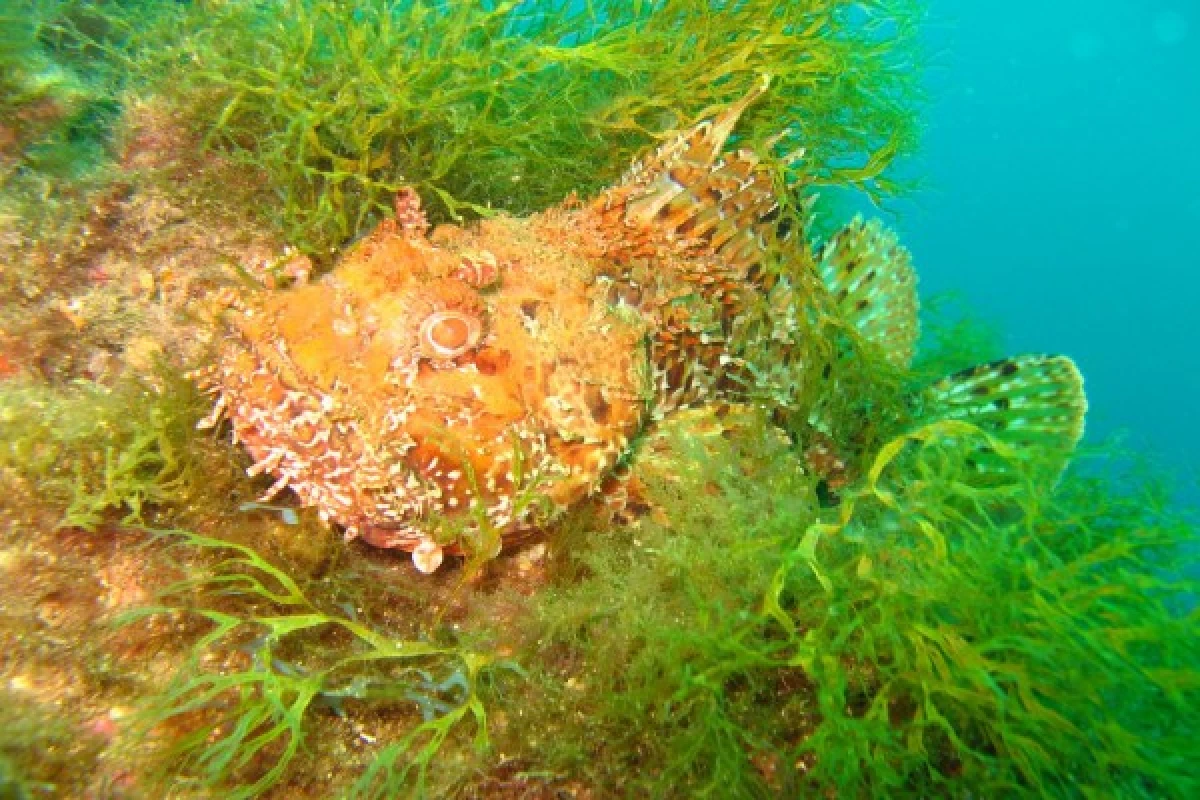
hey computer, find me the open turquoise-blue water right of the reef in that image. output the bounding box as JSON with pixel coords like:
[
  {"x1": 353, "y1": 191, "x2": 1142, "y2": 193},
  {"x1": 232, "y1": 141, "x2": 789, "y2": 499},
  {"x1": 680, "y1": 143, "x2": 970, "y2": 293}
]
[{"x1": 890, "y1": 0, "x2": 1200, "y2": 501}]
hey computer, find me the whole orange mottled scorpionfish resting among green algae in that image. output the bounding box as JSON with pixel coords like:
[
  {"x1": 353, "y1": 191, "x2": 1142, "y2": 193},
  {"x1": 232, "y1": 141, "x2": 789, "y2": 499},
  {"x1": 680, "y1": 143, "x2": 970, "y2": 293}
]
[{"x1": 198, "y1": 78, "x2": 1085, "y2": 572}]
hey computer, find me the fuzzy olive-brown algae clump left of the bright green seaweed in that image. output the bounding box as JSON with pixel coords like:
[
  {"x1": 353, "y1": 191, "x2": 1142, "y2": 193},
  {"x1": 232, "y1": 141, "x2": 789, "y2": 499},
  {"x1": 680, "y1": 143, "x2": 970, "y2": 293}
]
[{"x1": 504, "y1": 420, "x2": 817, "y2": 796}]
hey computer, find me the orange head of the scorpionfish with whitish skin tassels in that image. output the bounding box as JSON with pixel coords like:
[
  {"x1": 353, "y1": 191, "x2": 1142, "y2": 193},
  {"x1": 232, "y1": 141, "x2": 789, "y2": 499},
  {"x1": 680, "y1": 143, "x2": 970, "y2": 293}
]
[{"x1": 210, "y1": 209, "x2": 650, "y2": 566}]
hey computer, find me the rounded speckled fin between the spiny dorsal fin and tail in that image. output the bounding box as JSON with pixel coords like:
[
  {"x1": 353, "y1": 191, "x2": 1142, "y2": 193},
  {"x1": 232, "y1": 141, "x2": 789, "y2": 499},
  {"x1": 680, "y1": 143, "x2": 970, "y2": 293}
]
[{"x1": 817, "y1": 217, "x2": 918, "y2": 367}]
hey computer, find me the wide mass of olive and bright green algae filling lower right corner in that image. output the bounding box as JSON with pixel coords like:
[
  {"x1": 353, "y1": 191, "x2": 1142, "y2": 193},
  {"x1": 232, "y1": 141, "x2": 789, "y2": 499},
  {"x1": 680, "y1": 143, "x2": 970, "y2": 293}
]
[{"x1": 506, "y1": 328, "x2": 1200, "y2": 796}]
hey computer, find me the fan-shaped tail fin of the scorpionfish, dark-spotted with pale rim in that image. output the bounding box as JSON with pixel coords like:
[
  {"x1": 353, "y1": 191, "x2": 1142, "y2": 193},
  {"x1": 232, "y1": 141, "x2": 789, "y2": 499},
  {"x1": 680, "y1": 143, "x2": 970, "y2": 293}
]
[{"x1": 923, "y1": 355, "x2": 1087, "y2": 475}]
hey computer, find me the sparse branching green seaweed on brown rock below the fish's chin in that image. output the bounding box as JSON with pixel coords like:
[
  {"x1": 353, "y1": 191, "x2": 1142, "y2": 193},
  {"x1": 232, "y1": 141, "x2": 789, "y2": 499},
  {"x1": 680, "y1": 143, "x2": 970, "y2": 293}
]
[{"x1": 119, "y1": 530, "x2": 514, "y2": 799}]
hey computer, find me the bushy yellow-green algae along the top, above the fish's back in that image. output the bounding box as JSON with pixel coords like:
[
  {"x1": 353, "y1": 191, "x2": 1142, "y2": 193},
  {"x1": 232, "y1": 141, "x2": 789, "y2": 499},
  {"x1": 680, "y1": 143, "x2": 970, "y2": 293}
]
[{"x1": 110, "y1": 0, "x2": 917, "y2": 253}]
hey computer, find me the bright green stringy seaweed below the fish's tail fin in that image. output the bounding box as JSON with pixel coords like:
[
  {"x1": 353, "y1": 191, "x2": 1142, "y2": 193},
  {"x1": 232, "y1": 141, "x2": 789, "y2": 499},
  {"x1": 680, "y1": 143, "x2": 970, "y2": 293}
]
[{"x1": 766, "y1": 423, "x2": 1200, "y2": 796}]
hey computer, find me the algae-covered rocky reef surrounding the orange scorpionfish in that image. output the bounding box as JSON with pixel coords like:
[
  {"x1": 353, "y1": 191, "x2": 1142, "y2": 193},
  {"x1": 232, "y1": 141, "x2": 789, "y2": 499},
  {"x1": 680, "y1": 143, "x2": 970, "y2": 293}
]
[{"x1": 0, "y1": 0, "x2": 1200, "y2": 798}]
